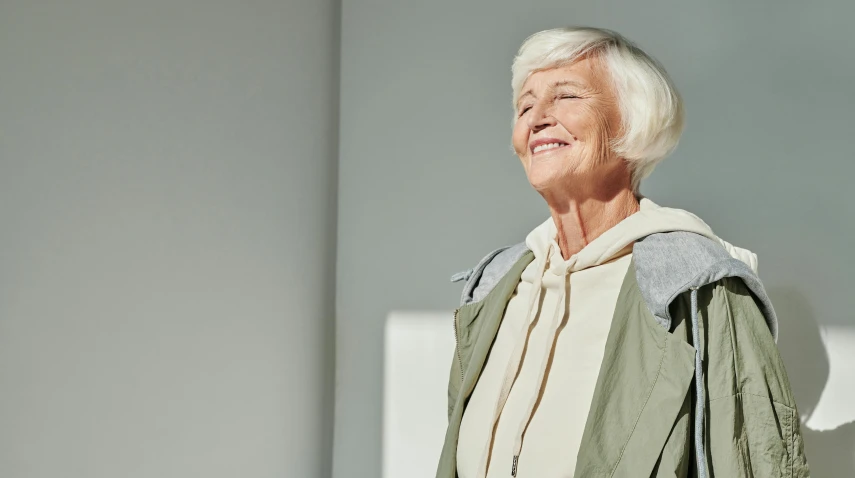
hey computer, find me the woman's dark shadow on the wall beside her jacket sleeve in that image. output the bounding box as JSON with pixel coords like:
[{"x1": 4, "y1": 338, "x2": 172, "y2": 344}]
[{"x1": 767, "y1": 287, "x2": 855, "y2": 478}]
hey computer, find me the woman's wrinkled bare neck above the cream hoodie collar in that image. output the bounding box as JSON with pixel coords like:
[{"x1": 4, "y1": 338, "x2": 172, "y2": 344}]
[{"x1": 544, "y1": 187, "x2": 640, "y2": 259}]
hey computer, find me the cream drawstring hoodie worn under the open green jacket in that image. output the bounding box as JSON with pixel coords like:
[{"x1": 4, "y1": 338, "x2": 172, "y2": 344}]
[{"x1": 457, "y1": 197, "x2": 757, "y2": 478}]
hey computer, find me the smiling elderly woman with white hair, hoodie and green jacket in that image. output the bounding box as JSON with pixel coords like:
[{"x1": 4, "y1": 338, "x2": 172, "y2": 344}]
[{"x1": 437, "y1": 28, "x2": 809, "y2": 478}]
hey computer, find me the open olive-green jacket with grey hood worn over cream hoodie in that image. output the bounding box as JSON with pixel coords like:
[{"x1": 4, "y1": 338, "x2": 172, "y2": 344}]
[{"x1": 436, "y1": 232, "x2": 809, "y2": 478}]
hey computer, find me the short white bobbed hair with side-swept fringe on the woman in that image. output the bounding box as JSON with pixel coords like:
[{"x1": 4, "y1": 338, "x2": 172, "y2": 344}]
[{"x1": 511, "y1": 27, "x2": 684, "y2": 193}]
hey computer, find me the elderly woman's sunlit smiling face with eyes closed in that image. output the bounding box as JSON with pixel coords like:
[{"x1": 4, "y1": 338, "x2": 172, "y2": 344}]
[{"x1": 512, "y1": 58, "x2": 625, "y2": 193}]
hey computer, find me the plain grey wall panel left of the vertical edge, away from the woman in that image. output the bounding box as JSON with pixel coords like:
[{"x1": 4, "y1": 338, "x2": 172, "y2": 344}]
[{"x1": 0, "y1": 0, "x2": 339, "y2": 478}]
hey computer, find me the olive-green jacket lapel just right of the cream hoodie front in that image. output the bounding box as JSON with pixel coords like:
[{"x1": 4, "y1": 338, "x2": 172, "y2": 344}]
[{"x1": 574, "y1": 260, "x2": 694, "y2": 477}]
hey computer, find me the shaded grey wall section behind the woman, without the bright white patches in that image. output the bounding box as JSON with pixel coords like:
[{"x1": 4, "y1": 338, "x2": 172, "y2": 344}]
[{"x1": 334, "y1": 0, "x2": 855, "y2": 478}]
